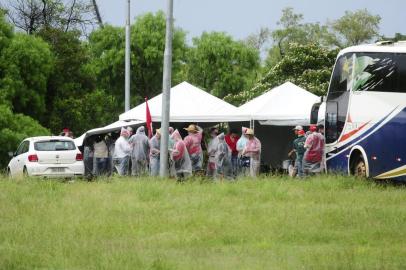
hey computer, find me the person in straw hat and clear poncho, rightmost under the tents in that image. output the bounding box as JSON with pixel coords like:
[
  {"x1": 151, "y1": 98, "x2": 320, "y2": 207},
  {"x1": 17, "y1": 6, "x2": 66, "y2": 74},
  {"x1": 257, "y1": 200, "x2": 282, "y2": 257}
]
[{"x1": 242, "y1": 128, "x2": 261, "y2": 177}]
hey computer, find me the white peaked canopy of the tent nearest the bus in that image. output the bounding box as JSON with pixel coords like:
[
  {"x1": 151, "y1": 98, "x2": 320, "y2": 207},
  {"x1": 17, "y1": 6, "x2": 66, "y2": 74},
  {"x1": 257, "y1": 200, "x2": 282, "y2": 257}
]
[{"x1": 238, "y1": 82, "x2": 320, "y2": 126}]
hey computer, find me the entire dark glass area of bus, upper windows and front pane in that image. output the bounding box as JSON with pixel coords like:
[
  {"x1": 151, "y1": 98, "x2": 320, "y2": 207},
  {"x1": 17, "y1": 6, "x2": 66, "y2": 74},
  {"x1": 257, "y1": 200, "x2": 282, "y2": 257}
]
[{"x1": 325, "y1": 52, "x2": 406, "y2": 143}]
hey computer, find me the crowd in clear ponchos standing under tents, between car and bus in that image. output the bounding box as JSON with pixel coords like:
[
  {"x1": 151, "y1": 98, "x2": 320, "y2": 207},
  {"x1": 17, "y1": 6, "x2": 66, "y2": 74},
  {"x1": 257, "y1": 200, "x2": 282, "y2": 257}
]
[{"x1": 84, "y1": 124, "x2": 261, "y2": 179}]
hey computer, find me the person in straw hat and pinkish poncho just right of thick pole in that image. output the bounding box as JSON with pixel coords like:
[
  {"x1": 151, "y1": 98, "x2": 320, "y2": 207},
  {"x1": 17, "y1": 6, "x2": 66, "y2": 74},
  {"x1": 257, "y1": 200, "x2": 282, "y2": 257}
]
[{"x1": 183, "y1": 124, "x2": 203, "y2": 173}]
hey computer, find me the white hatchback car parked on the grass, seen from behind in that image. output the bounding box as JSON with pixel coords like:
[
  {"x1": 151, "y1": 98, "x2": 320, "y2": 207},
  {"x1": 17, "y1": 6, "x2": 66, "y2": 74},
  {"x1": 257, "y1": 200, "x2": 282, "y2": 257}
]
[{"x1": 7, "y1": 136, "x2": 85, "y2": 177}]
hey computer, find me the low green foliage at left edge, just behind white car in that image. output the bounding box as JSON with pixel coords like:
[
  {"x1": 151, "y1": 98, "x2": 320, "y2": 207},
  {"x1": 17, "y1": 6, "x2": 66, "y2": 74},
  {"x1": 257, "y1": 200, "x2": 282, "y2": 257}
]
[{"x1": 0, "y1": 105, "x2": 49, "y2": 169}]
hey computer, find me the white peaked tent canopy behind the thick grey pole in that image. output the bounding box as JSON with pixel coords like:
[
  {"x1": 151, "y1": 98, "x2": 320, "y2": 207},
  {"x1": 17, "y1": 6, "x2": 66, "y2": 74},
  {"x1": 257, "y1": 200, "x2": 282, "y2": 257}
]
[{"x1": 119, "y1": 82, "x2": 244, "y2": 123}]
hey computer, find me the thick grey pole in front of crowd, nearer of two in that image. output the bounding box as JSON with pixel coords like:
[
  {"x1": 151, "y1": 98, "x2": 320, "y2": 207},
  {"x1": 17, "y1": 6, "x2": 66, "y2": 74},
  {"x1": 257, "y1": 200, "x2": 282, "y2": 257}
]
[{"x1": 159, "y1": 0, "x2": 173, "y2": 177}]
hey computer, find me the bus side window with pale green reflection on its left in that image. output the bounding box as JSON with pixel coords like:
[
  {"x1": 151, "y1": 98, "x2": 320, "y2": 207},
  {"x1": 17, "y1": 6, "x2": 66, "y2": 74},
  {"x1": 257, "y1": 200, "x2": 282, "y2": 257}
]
[{"x1": 352, "y1": 52, "x2": 396, "y2": 92}]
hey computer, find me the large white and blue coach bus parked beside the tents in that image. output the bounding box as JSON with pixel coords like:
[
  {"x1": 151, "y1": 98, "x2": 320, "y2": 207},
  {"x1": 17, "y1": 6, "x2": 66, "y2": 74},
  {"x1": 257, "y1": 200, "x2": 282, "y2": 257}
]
[{"x1": 311, "y1": 42, "x2": 406, "y2": 181}]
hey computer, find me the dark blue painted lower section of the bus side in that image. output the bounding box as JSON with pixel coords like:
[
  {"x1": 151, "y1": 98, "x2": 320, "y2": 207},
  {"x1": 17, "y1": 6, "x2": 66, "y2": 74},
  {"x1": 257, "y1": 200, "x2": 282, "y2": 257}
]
[{"x1": 327, "y1": 108, "x2": 406, "y2": 180}]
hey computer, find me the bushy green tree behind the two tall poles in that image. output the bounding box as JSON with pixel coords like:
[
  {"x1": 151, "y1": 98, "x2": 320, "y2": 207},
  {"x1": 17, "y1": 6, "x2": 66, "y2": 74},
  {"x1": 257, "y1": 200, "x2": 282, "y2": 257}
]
[{"x1": 88, "y1": 12, "x2": 186, "y2": 106}]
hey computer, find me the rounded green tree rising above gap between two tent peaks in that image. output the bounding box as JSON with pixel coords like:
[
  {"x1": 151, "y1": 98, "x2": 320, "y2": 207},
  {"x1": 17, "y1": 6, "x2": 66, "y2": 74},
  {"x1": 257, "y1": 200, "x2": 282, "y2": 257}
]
[{"x1": 187, "y1": 32, "x2": 260, "y2": 101}]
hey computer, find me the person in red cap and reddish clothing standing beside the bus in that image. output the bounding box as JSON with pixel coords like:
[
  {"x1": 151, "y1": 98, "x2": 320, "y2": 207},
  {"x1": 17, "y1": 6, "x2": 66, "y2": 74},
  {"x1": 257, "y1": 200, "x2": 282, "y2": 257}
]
[{"x1": 303, "y1": 125, "x2": 324, "y2": 175}]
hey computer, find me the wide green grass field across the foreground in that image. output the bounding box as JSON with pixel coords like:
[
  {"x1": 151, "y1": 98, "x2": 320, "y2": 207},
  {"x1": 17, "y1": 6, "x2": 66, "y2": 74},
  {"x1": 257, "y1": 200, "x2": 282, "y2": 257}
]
[{"x1": 0, "y1": 176, "x2": 406, "y2": 269}]
